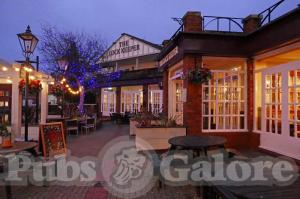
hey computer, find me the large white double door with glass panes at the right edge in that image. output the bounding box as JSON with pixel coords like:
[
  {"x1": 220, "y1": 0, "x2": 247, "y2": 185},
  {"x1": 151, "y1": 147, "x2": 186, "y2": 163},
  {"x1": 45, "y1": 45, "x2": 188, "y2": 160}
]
[{"x1": 261, "y1": 62, "x2": 300, "y2": 159}]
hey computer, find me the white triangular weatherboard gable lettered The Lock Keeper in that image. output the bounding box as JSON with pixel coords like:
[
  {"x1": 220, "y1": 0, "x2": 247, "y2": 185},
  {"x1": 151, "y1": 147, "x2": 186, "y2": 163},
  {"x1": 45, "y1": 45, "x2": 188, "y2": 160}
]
[{"x1": 100, "y1": 34, "x2": 160, "y2": 63}]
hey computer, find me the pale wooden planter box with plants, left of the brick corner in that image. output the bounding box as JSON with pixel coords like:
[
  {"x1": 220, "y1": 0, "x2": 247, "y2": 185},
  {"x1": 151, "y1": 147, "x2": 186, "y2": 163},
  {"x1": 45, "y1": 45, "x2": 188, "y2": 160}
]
[{"x1": 134, "y1": 127, "x2": 186, "y2": 150}]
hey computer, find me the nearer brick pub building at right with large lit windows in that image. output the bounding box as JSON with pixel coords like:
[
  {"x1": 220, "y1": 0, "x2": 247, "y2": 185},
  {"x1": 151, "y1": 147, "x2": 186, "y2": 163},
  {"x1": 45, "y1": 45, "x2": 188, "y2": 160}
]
[{"x1": 158, "y1": 4, "x2": 300, "y2": 160}]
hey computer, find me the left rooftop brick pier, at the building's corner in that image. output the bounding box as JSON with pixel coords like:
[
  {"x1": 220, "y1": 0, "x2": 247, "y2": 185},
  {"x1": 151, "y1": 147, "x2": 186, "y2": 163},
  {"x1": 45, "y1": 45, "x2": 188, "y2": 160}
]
[{"x1": 182, "y1": 11, "x2": 202, "y2": 32}]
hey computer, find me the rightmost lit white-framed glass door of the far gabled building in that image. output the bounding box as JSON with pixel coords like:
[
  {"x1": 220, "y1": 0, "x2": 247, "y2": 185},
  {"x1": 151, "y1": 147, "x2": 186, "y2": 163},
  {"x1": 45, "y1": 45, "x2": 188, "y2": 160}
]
[{"x1": 148, "y1": 90, "x2": 163, "y2": 114}]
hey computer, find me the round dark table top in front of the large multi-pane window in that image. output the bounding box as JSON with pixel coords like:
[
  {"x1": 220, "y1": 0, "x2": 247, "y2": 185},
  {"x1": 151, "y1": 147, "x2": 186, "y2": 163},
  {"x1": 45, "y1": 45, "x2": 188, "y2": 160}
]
[{"x1": 168, "y1": 136, "x2": 226, "y2": 156}]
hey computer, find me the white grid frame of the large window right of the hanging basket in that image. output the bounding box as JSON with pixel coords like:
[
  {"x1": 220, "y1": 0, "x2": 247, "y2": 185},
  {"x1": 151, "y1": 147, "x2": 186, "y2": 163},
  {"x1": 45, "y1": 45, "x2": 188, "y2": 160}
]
[{"x1": 202, "y1": 67, "x2": 248, "y2": 133}]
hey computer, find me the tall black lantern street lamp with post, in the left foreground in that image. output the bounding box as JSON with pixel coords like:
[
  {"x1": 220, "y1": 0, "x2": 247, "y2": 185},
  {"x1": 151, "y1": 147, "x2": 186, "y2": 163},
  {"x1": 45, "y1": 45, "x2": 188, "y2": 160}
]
[{"x1": 17, "y1": 26, "x2": 39, "y2": 141}]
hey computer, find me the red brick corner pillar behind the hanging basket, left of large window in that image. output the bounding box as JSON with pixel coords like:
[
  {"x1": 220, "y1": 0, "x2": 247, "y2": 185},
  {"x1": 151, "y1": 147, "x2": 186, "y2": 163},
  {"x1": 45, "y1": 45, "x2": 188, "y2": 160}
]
[{"x1": 183, "y1": 55, "x2": 202, "y2": 135}]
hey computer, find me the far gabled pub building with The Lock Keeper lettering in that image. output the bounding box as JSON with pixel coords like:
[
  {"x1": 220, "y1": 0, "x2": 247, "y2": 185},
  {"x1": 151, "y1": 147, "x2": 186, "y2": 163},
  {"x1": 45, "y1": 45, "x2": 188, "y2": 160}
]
[{"x1": 97, "y1": 33, "x2": 163, "y2": 117}]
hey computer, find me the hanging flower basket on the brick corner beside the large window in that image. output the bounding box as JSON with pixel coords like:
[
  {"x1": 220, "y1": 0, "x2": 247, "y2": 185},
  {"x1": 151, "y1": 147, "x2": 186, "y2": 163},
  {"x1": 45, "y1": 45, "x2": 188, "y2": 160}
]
[{"x1": 189, "y1": 68, "x2": 212, "y2": 84}]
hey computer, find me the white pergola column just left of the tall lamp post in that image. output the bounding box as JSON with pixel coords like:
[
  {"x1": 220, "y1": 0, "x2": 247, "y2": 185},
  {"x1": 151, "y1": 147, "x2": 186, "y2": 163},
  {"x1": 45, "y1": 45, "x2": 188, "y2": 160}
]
[{"x1": 11, "y1": 76, "x2": 22, "y2": 140}]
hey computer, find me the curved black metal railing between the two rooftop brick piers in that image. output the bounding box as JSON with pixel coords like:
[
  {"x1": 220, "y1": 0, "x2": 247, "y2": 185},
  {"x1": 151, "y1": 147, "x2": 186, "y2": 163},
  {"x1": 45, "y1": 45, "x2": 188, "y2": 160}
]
[{"x1": 202, "y1": 16, "x2": 244, "y2": 32}]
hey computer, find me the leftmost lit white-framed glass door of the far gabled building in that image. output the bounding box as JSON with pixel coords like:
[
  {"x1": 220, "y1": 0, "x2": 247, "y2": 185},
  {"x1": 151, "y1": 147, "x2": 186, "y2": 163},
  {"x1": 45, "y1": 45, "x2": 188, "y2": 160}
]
[{"x1": 102, "y1": 91, "x2": 116, "y2": 116}]
